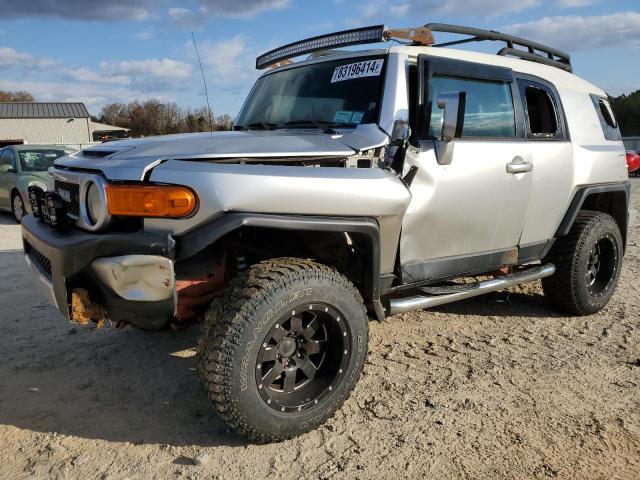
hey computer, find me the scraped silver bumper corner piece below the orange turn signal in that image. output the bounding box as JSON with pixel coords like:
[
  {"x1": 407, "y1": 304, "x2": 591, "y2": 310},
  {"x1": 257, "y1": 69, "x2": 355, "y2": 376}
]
[{"x1": 91, "y1": 255, "x2": 175, "y2": 302}]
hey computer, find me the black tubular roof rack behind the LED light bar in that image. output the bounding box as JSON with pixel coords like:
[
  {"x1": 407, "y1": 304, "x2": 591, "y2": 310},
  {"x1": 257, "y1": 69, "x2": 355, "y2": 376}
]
[{"x1": 424, "y1": 23, "x2": 573, "y2": 72}]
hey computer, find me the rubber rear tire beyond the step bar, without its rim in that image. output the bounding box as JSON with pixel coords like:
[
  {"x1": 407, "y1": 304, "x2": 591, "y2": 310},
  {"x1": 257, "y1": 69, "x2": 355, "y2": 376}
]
[{"x1": 542, "y1": 210, "x2": 624, "y2": 315}]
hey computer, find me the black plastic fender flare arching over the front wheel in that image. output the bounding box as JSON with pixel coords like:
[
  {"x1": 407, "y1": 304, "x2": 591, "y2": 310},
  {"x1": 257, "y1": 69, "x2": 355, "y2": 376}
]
[{"x1": 175, "y1": 213, "x2": 380, "y2": 300}]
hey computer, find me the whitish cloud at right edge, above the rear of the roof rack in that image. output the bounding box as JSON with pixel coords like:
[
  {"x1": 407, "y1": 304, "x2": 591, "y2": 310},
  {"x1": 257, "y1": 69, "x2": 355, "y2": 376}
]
[{"x1": 503, "y1": 12, "x2": 640, "y2": 51}]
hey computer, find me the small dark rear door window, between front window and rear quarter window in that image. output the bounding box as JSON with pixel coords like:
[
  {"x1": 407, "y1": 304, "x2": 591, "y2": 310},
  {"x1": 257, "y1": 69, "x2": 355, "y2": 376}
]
[{"x1": 518, "y1": 79, "x2": 565, "y2": 140}]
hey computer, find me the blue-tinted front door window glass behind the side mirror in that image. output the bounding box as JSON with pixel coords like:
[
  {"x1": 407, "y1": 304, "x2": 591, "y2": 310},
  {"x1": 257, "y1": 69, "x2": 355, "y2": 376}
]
[{"x1": 425, "y1": 75, "x2": 516, "y2": 138}]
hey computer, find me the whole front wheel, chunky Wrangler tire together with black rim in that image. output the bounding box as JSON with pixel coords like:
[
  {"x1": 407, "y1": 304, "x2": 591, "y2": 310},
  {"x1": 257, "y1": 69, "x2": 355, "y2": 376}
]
[{"x1": 198, "y1": 258, "x2": 368, "y2": 443}]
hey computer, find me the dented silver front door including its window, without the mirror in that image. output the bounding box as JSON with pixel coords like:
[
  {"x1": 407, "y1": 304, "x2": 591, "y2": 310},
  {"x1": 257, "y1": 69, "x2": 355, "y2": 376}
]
[{"x1": 400, "y1": 56, "x2": 533, "y2": 282}]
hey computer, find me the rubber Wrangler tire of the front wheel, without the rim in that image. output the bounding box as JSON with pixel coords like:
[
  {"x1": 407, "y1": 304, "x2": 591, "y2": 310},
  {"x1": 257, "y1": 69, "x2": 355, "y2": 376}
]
[{"x1": 197, "y1": 258, "x2": 368, "y2": 443}]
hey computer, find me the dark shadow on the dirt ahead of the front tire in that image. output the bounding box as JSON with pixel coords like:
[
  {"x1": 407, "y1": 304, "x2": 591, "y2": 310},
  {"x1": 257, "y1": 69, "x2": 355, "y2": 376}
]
[{"x1": 0, "y1": 251, "x2": 244, "y2": 446}]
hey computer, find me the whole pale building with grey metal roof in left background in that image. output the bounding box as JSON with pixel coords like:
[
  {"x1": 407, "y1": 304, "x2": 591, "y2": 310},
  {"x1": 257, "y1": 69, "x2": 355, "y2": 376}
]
[{"x1": 0, "y1": 102, "x2": 126, "y2": 148}]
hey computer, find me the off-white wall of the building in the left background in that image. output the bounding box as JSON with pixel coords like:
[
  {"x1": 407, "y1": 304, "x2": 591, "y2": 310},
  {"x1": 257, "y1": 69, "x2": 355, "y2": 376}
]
[{"x1": 0, "y1": 118, "x2": 92, "y2": 144}]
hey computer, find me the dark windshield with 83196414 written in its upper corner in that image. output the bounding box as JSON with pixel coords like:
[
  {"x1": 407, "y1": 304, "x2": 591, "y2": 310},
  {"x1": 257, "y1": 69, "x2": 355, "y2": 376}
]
[{"x1": 236, "y1": 55, "x2": 385, "y2": 129}]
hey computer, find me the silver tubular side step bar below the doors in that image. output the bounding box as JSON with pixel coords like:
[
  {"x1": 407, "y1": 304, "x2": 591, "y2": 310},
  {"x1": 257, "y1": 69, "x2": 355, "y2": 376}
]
[{"x1": 389, "y1": 263, "x2": 556, "y2": 315}]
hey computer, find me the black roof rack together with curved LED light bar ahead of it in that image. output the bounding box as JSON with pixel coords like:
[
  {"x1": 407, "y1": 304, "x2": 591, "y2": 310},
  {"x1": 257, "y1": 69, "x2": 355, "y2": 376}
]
[{"x1": 256, "y1": 23, "x2": 572, "y2": 72}]
